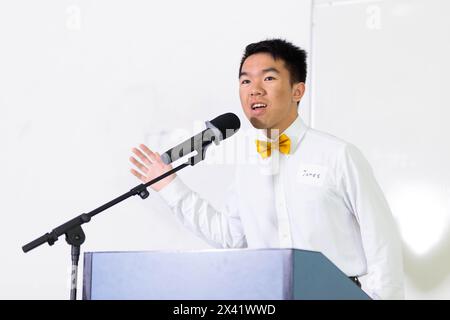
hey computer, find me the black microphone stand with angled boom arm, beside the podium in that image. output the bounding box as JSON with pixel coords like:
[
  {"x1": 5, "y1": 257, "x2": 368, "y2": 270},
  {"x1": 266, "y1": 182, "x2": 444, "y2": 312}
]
[{"x1": 22, "y1": 156, "x2": 197, "y2": 300}]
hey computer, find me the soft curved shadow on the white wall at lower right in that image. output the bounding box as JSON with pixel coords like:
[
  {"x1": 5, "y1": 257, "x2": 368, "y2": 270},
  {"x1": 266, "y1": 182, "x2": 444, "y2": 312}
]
[{"x1": 403, "y1": 228, "x2": 450, "y2": 291}]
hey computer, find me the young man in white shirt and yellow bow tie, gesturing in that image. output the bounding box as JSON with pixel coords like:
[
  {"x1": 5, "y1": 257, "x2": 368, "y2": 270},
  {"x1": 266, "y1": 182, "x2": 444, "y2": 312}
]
[{"x1": 130, "y1": 39, "x2": 403, "y2": 299}]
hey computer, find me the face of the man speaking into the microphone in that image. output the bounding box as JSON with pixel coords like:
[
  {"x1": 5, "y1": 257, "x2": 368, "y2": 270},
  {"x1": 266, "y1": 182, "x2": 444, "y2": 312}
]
[{"x1": 239, "y1": 53, "x2": 304, "y2": 136}]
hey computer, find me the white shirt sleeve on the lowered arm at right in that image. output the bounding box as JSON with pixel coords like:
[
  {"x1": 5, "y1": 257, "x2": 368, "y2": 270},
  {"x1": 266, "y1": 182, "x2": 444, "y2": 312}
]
[{"x1": 341, "y1": 144, "x2": 404, "y2": 299}]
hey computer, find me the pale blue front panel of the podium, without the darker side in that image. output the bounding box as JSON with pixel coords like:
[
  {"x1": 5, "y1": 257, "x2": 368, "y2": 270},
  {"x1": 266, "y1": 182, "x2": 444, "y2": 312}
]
[{"x1": 83, "y1": 249, "x2": 292, "y2": 300}]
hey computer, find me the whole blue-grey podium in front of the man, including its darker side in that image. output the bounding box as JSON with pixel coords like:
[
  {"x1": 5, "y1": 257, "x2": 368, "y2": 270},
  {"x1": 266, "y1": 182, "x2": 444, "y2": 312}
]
[{"x1": 83, "y1": 249, "x2": 370, "y2": 300}]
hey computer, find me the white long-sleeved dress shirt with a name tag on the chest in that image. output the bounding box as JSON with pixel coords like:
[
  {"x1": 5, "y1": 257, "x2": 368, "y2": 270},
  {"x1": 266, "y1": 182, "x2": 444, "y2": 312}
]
[{"x1": 159, "y1": 117, "x2": 404, "y2": 299}]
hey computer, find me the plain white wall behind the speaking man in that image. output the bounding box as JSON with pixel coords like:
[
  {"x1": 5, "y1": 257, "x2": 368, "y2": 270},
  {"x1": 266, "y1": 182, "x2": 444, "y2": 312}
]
[{"x1": 0, "y1": 0, "x2": 450, "y2": 299}]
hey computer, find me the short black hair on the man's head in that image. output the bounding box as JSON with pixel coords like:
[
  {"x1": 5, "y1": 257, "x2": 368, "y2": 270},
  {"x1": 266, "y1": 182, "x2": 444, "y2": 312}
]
[{"x1": 239, "y1": 39, "x2": 307, "y2": 84}]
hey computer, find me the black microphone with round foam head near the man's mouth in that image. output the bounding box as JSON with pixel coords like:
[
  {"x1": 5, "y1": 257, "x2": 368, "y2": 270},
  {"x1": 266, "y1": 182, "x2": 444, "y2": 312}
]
[{"x1": 161, "y1": 112, "x2": 241, "y2": 165}]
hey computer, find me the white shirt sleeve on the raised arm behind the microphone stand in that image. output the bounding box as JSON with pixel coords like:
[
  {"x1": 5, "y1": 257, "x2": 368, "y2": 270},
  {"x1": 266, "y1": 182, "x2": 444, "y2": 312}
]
[{"x1": 158, "y1": 176, "x2": 247, "y2": 248}]
